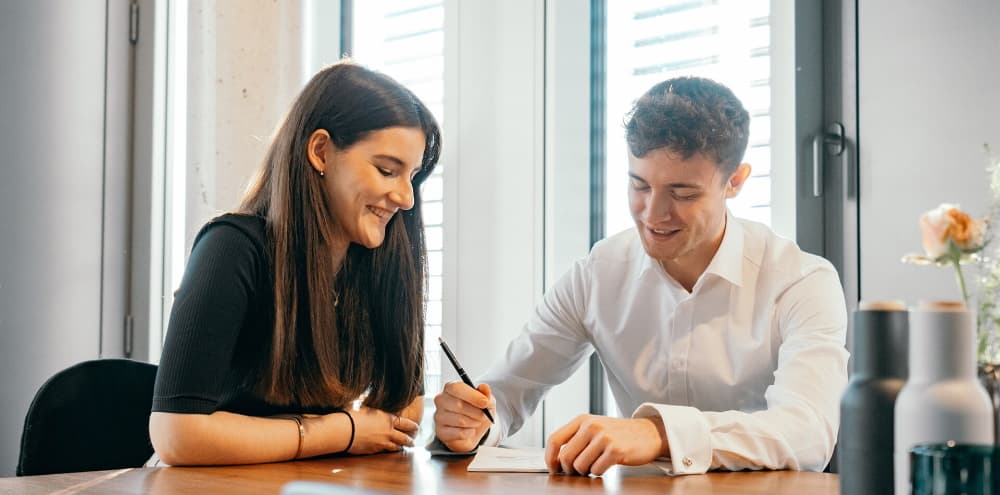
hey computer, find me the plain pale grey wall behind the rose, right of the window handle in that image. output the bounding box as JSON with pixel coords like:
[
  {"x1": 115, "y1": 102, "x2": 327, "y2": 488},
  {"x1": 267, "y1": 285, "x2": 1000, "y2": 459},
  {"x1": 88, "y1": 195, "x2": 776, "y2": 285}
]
[{"x1": 858, "y1": 0, "x2": 1000, "y2": 304}]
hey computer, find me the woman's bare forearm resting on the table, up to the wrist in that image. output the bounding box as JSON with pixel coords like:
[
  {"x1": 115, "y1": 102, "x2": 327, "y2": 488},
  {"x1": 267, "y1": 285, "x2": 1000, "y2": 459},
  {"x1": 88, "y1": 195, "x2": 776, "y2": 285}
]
[{"x1": 149, "y1": 411, "x2": 352, "y2": 466}]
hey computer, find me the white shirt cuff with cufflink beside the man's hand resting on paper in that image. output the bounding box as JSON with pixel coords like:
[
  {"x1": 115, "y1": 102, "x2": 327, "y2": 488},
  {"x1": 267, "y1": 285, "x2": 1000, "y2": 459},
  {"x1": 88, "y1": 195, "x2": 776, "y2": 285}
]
[{"x1": 632, "y1": 402, "x2": 712, "y2": 474}]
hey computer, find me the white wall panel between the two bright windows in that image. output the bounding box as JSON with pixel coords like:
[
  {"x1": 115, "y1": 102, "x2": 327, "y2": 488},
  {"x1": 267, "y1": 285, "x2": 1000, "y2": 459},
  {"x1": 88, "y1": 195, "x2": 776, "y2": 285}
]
[{"x1": 441, "y1": 0, "x2": 544, "y2": 450}]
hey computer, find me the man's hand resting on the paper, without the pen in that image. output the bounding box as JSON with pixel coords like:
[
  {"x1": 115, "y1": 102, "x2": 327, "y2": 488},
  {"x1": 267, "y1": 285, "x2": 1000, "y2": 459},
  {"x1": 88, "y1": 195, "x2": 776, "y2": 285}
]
[{"x1": 545, "y1": 414, "x2": 670, "y2": 476}]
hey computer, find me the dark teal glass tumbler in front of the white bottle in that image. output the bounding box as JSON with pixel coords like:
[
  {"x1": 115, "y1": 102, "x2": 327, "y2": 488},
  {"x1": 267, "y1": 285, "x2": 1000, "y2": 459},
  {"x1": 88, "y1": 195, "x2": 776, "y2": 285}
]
[{"x1": 910, "y1": 442, "x2": 1000, "y2": 495}]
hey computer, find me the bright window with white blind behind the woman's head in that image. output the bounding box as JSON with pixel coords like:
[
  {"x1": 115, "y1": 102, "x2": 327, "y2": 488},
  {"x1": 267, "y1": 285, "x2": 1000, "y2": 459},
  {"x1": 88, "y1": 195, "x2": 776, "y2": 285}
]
[{"x1": 351, "y1": 0, "x2": 444, "y2": 393}]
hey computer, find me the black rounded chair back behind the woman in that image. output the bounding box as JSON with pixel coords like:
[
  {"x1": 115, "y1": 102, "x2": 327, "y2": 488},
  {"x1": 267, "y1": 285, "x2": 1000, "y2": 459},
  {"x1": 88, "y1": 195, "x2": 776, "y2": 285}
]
[{"x1": 17, "y1": 359, "x2": 156, "y2": 476}]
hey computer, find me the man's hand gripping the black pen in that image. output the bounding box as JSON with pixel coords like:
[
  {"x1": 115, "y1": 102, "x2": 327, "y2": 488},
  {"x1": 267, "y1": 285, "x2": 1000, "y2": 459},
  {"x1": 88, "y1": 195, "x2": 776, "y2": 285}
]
[{"x1": 434, "y1": 381, "x2": 496, "y2": 452}]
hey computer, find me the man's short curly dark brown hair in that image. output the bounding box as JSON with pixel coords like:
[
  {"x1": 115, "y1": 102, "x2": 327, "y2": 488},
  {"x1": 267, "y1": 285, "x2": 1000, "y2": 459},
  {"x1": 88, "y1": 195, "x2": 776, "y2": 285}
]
[{"x1": 625, "y1": 77, "x2": 750, "y2": 177}]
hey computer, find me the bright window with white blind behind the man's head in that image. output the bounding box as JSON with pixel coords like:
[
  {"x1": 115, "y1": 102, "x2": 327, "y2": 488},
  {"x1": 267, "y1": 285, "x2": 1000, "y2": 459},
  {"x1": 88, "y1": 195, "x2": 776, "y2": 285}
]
[{"x1": 605, "y1": 0, "x2": 771, "y2": 235}]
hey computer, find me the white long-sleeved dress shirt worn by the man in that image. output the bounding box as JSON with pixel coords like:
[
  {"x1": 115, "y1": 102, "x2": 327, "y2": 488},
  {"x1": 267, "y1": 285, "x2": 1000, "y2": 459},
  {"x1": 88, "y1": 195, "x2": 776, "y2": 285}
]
[{"x1": 480, "y1": 214, "x2": 848, "y2": 474}]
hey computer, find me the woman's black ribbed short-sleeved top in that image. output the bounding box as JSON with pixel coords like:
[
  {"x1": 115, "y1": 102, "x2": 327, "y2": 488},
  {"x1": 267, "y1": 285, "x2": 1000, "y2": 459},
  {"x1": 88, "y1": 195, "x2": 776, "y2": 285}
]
[{"x1": 153, "y1": 214, "x2": 335, "y2": 416}]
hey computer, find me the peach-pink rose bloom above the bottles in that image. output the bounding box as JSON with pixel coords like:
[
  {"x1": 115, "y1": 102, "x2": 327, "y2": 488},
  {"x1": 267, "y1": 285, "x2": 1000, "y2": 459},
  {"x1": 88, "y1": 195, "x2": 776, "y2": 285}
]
[{"x1": 920, "y1": 203, "x2": 986, "y2": 259}]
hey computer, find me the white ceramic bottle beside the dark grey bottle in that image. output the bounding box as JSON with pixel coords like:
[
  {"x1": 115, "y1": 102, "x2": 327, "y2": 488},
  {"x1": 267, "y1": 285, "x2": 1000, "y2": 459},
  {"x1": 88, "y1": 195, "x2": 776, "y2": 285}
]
[{"x1": 894, "y1": 301, "x2": 993, "y2": 495}]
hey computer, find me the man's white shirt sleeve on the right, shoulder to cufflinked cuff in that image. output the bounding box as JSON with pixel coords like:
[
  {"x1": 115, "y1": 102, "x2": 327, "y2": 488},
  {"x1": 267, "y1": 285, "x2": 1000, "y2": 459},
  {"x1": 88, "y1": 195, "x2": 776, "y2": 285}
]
[{"x1": 632, "y1": 268, "x2": 848, "y2": 474}]
